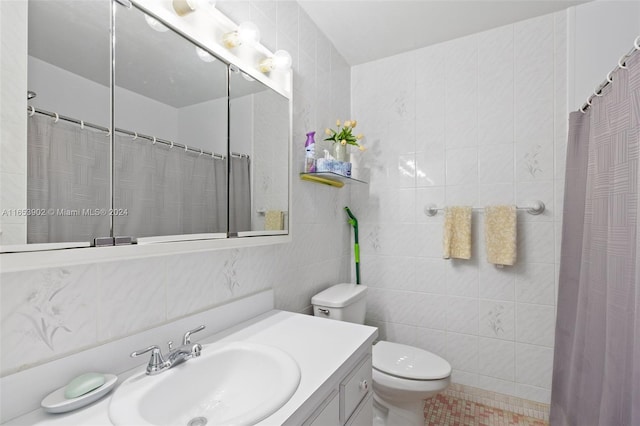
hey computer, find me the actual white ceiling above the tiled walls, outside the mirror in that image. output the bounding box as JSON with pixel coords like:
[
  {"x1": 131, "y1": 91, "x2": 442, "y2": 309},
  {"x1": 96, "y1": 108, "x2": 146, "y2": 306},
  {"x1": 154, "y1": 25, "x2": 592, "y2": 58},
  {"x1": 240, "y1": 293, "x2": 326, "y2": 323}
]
[{"x1": 299, "y1": 0, "x2": 590, "y2": 65}]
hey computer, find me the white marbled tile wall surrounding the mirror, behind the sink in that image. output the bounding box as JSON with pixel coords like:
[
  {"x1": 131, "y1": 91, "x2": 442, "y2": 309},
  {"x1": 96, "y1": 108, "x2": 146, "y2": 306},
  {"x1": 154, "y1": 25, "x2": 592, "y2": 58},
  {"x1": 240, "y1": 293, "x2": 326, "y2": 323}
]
[{"x1": 0, "y1": 1, "x2": 351, "y2": 375}]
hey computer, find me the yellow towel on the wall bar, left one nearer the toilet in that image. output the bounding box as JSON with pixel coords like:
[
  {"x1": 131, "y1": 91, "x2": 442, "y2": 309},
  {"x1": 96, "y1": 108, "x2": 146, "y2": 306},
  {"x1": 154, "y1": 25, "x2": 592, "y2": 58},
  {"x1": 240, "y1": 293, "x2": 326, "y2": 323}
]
[{"x1": 442, "y1": 206, "x2": 471, "y2": 259}]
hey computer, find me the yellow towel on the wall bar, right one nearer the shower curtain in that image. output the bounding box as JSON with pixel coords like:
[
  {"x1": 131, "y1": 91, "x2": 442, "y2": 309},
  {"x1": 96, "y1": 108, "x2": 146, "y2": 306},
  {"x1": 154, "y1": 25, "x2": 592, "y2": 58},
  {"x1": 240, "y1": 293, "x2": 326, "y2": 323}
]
[{"x1": 484, "y1": 206, "x2": 516, "y2": 266}]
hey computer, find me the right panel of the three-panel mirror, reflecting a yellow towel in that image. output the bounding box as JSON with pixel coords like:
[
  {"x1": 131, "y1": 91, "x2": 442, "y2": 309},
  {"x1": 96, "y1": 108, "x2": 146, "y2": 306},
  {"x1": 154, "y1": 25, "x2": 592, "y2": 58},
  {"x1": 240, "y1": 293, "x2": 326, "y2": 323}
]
[{"x1": 229, "y1": 71, "x2": 290, "y2": 237}]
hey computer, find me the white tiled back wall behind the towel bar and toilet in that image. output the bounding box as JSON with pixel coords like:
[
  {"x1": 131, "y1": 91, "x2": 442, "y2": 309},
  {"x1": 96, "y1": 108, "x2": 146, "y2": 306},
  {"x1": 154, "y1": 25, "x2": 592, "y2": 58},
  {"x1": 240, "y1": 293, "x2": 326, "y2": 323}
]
[{"x1": 351, "y1": 12, "x2": 568, "y2": 402}]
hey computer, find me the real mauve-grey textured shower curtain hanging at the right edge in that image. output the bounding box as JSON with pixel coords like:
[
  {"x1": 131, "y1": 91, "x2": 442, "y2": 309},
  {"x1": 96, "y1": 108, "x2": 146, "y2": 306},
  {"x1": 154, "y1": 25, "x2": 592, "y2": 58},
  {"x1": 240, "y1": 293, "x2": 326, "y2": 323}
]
[{"x1": 550, "y1": 53, "x2": 640, "y2": 426}]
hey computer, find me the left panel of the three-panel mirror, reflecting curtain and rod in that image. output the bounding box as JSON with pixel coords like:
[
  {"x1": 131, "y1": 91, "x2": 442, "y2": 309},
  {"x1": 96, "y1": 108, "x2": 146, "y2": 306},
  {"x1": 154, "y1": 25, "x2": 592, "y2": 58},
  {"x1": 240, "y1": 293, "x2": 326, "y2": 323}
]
[{"x1": 21, "y1": 0, "x2": 111, "y2": 245}]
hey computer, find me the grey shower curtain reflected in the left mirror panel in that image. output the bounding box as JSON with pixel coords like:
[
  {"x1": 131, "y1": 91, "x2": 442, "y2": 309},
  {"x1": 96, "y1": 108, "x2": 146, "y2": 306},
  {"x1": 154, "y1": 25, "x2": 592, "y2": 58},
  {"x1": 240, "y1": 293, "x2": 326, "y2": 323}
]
[{"x1": 27, "y1": 115, "x2": 111, "y2": 244}]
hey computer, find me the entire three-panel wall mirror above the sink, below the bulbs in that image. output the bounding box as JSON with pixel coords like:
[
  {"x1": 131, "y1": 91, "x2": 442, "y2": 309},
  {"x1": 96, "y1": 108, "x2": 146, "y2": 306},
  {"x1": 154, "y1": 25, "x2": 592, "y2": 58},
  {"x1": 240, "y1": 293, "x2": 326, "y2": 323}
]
[{"x1": 2, "y1": 0, "x2": 291, "y2": 252}]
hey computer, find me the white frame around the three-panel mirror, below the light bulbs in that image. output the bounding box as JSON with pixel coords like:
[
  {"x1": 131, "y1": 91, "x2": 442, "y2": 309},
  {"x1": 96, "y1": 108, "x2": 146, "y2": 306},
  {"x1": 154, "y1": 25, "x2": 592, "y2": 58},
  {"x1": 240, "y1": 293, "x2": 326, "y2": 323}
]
[{"x1": 0, "y1": 0, "x2": 293, "y2": 272}]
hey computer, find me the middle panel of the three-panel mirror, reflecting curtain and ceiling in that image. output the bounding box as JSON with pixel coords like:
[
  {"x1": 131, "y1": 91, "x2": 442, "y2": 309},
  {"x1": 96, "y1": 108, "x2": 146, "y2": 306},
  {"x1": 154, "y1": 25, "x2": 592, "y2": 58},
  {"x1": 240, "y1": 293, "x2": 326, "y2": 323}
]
[{"x1": 114, "y1": 6, "x2": 228, "y2": 243}]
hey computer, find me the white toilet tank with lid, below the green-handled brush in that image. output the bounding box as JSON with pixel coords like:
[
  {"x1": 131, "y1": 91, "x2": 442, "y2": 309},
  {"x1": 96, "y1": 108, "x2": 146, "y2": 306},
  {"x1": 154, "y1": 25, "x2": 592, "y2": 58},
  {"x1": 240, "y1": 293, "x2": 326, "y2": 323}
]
[{"x1": 311, "y1": 284, "x2": 367, "y2": 324}]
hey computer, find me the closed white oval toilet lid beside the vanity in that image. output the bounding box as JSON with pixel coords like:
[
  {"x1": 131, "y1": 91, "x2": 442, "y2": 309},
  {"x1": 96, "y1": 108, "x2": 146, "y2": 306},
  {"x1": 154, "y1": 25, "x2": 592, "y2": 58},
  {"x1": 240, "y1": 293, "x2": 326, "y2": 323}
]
[{"x1": 372, "y1": 341, "x2": 451, "y2": 380}]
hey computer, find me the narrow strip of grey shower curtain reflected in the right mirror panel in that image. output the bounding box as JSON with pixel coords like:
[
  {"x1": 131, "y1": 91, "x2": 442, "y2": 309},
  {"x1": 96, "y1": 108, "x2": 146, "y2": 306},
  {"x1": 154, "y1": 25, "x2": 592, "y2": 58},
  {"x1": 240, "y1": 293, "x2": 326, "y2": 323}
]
[{"x1": 229, "y1": 156, "x2": 251, "y2": 233}]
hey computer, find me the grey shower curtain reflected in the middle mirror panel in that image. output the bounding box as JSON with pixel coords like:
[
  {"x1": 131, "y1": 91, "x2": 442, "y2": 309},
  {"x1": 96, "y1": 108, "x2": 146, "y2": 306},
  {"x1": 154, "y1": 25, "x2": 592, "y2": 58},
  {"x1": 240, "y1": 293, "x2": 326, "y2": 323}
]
[{"x1": 114, "y1": 133, "x2": 227, "y2": 237}]
